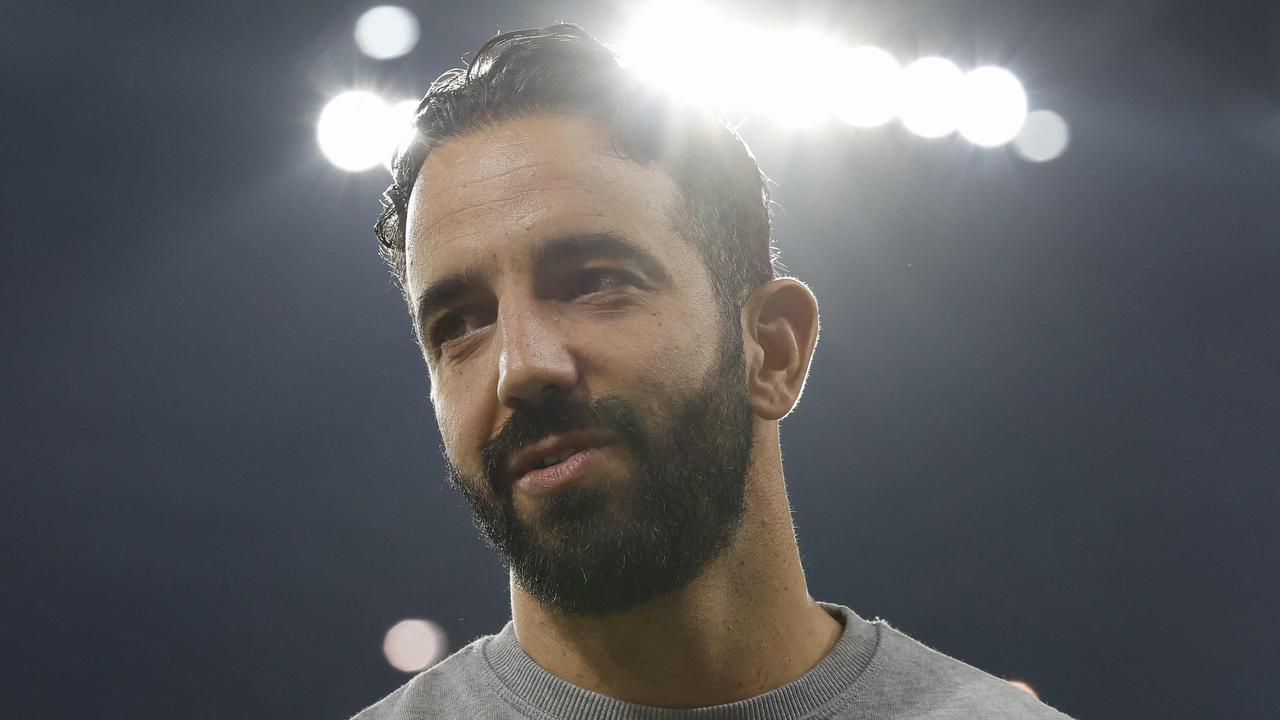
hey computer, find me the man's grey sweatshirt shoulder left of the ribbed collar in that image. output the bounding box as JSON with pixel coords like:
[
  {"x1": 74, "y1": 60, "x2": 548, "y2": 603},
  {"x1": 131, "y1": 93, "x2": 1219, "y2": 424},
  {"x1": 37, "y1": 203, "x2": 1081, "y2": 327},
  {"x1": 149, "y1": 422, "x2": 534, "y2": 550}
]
[{"x1": 351, "y1": 635, "x2": 493, "y2": 720}]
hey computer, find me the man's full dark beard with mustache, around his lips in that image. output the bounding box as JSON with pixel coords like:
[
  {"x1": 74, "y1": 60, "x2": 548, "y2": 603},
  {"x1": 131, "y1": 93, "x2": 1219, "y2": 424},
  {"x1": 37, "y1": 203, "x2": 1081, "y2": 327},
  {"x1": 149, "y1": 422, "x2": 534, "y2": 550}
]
[{"x1": 445, "y1": 316, "x2": 751, "y2": 616}]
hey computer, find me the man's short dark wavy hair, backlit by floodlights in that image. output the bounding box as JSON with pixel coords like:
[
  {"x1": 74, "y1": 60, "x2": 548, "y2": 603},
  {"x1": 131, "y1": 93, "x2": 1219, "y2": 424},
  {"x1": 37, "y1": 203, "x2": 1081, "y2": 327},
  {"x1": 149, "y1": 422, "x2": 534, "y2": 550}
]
[{"x1": 374, "y1": 24, "x2": 780, "y2": 315}]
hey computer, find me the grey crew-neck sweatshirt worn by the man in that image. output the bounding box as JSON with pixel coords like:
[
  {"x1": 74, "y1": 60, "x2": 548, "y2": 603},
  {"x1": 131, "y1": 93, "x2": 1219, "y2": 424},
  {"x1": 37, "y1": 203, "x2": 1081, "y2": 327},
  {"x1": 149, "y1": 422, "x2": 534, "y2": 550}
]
[{"x1": 353, "y1": 602, "x2": 1070, "y2": 720}]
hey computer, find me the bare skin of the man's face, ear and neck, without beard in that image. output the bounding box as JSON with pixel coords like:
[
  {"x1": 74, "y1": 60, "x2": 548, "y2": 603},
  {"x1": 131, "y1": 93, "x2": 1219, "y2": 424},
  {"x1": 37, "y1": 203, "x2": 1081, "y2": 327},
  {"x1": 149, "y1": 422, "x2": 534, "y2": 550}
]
[{"x1": 406, "y1": 114, "x2": 842, "y2": 707}]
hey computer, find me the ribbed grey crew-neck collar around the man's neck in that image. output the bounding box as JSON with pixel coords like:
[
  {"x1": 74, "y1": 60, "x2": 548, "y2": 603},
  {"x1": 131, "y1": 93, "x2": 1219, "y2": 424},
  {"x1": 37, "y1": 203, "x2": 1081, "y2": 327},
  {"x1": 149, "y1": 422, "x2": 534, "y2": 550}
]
[{"x1": 484, "y1": 602, "x2": 881, "y2": 720}]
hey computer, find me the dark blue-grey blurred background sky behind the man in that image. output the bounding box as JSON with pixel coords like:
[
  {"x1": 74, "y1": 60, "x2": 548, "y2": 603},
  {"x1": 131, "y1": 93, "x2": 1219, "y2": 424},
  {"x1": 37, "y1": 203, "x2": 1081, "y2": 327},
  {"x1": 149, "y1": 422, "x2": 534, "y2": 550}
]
[{"x1": 0, "y1": 0, "x2": 1280, "y2": 719}]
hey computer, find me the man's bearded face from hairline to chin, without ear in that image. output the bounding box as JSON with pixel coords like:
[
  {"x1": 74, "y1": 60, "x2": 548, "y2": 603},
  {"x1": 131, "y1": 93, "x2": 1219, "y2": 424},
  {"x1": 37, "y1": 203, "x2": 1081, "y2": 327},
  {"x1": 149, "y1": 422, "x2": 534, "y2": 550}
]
[{"x1": 406, "y1": 114, "x2": 753, "y2": 615}]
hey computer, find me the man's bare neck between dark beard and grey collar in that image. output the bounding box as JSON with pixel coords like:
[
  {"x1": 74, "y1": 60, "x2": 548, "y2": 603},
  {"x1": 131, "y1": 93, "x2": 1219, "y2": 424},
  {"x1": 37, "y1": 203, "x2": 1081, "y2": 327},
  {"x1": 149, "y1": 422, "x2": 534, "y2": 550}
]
[{"x1": 511, "y1": 424, "x2": 841, "y2": 707}]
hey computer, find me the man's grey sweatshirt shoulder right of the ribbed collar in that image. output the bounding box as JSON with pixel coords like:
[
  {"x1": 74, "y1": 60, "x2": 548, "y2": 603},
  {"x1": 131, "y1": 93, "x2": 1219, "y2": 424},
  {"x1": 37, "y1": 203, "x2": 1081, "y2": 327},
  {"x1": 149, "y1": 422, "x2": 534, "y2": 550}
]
[{"x1": 864, "y1": 620, "x2": 1070, "y2": 720}]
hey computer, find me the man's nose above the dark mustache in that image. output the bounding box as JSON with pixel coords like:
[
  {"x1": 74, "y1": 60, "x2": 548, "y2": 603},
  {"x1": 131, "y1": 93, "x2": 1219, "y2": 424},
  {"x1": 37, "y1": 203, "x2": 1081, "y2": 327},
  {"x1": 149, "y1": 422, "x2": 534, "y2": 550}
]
[{"x1": 497, "y1": 298, "x2": 579, "y2": 407}]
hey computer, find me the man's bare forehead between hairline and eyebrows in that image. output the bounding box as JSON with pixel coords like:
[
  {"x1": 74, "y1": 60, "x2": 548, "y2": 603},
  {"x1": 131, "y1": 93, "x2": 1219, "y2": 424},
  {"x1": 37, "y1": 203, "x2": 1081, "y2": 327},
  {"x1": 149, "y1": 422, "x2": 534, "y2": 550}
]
[{"x1": 404, "y1": 114, "x2": 680, "y2": 284}]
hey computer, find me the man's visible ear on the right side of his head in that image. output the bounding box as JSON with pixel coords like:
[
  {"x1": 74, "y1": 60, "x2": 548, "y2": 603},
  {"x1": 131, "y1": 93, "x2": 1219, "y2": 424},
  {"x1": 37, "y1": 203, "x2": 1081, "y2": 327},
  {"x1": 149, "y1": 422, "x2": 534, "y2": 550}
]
[{"x1": 742, "y1": 278, "x2": 818, "y2": 420}]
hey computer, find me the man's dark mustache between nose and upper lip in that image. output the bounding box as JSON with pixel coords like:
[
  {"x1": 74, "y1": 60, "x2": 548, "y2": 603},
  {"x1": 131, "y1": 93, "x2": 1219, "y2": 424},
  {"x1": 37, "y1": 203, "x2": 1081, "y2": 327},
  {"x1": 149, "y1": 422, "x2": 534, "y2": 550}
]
[{"x1": 480, "y1": 392, "x2": 648, "y2": 493}]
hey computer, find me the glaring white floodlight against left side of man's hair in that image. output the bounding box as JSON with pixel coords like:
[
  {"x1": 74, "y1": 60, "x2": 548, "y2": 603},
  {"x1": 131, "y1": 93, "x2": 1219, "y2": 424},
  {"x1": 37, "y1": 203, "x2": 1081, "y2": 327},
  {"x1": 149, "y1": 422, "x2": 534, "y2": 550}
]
[{"x1": 316, "y1": 90, "x2": 417, "y2": 173}]
